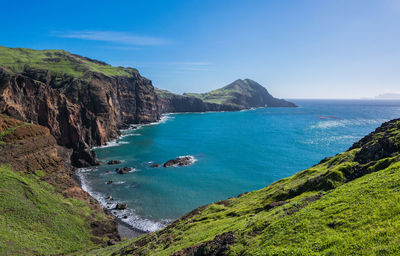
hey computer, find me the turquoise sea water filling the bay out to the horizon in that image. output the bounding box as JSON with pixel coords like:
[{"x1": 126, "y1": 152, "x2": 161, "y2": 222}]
[{"x1": 79, "y1": 100, "x2": 400, "y2": 231}]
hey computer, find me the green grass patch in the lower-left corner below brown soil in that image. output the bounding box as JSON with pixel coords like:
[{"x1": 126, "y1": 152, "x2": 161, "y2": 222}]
[{"x1": 0, "y1": 166, "x2": 104, "y2": 255}]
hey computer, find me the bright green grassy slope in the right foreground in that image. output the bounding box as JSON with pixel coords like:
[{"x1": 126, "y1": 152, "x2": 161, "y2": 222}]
[{"x1": 88, "y1": 121, "x2": 400, "y2": 255}]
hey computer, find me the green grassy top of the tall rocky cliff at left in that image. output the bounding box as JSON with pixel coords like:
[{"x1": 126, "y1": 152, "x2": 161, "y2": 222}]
[{"x1": 0, "y1": 46, "x2": 137, "y2": 77}]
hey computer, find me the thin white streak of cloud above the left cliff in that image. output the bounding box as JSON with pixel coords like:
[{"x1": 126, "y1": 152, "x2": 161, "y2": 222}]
[{"x1": 54, "y1": 31, "x2": 171, "y2": 46}]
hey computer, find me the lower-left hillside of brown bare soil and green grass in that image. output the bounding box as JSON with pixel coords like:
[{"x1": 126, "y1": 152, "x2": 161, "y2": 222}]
[{"x1": 0, "y1": 115, "x2": 114, "y2": 255}]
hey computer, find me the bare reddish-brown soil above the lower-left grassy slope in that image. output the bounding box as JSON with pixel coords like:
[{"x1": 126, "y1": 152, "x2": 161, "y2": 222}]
[{"x1": 0, "y1": 115, "x2": 119, "y2": 243}]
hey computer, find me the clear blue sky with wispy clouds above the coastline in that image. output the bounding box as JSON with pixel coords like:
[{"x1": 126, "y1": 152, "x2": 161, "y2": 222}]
[{"x1": 0, "y1": 0, "x2": 400, "y2": 98}]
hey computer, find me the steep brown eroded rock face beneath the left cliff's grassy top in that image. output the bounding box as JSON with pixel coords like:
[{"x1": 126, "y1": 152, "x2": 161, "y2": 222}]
[{"x1": 0, "y1": 68, "x2": 160, "y2": 167}]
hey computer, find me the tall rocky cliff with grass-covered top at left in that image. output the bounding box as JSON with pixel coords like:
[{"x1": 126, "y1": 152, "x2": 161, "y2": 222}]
[{"x1": 0, "y1": 47, "x2": 160, "y2": 167}]
